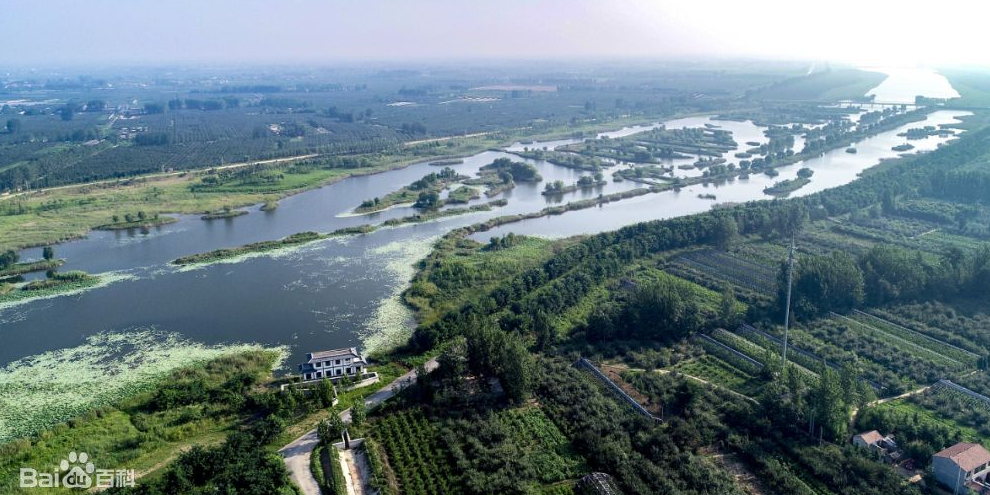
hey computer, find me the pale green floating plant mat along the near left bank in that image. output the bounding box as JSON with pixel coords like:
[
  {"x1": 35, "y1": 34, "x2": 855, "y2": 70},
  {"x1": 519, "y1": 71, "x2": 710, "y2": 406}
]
[{"x1": 0, "y1": 329, "x2": 286, "y2": 444}]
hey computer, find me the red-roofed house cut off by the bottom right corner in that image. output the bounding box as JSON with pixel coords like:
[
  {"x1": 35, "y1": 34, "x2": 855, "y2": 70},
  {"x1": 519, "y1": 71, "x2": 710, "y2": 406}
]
[{"x1": 932, "y1": 443, "x2": 990, "y2": 494}]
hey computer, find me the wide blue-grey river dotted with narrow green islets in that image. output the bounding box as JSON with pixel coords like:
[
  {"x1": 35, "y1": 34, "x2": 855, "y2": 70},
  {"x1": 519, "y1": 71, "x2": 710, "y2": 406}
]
[{"x1": 0, "y1": 66, "x2": 965, "y2": 388}]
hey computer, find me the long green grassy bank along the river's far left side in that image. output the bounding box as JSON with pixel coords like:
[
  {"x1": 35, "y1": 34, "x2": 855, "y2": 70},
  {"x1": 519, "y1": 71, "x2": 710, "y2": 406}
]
[{"x1": 0, "y1": 114, "x2": 686, "y2": 251}]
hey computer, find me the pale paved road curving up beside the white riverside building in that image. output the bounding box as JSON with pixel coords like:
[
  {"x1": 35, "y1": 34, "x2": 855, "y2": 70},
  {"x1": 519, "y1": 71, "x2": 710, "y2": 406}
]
[{"x1": 278, "y1": 359, "x2": 438, "y2": 495}]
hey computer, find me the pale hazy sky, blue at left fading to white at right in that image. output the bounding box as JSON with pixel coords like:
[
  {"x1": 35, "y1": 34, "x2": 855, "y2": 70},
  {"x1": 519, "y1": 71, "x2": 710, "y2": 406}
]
[{"x1": 0, "y1": 0, "x2": 990, "y2": 66}]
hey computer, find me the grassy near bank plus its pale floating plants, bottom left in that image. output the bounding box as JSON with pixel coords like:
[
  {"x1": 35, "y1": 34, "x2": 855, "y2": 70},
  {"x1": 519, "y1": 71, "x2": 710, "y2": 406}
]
[{"x1": 0, "y1": 346, "x2": 285, "y2": 494}]
